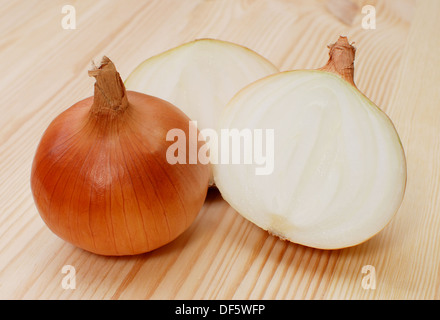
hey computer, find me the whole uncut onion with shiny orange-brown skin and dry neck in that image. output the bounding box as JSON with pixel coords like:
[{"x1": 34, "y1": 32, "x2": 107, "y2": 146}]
[{"x1": 31, "y1": 57, "x2": 210, "y2": 256}]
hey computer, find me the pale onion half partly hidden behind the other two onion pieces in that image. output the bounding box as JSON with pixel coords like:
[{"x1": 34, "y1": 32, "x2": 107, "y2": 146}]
[{"x1": 125, "y1": 39, "x2": 278, "y2": 129}]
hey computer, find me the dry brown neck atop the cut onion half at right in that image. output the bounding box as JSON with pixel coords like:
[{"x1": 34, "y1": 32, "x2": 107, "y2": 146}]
[{"x1": 318, "y1": 36, "x2": 356, "y2": 86}]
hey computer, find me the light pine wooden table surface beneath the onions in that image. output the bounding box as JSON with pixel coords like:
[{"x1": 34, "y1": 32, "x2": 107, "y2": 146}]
[{"x1": 0, "y1": 0, "x2": 440, "y2": 299}]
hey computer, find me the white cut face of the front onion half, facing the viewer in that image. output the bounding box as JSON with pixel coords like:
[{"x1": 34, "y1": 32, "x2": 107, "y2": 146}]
[{"x1": 214, "y1": 71, "x2": 406, "y2": 249}]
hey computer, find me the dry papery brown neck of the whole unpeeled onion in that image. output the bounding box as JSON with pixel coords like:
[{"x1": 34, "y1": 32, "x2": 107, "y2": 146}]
[{"x1": 89, "y1": 56, "x2": 129, "y2": 115}]
